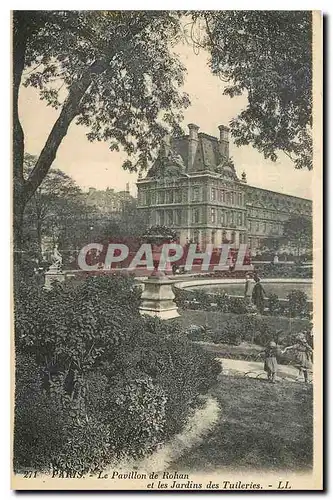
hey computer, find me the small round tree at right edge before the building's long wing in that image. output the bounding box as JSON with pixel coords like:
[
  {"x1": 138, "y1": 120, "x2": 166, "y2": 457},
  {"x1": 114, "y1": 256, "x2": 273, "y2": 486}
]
[{"x1": 284, "y1": 215, "x2": 312, "y2": 257}]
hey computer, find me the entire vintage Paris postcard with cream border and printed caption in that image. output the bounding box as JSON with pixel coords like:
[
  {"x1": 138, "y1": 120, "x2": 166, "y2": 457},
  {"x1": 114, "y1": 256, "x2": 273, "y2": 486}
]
[{"x1": 11, "y1": 10, "x2": 323, "y2": 493}]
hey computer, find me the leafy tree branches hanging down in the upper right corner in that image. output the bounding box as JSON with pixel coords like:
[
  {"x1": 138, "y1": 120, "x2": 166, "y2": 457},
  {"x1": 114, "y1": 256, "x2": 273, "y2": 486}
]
[{"x1": 190, "y1": 10, "x2": 312, "y2": 170}]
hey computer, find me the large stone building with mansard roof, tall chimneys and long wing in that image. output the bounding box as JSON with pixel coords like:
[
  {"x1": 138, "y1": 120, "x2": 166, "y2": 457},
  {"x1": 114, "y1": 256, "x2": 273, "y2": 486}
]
[{"x1": 137, "y1": 124, "x2": 312, "y2": 250}]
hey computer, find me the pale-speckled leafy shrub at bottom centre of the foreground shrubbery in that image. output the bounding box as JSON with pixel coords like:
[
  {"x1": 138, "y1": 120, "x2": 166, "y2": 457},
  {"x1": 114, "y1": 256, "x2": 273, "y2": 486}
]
[{"x1": 87, "y1": 370, "x2": 166, "y2": 458}]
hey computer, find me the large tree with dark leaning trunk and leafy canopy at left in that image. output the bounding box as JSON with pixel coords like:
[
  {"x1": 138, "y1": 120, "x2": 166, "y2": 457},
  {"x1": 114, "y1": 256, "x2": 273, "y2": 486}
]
[{"x1": 13, "y1": 11, "x2": 188, "y2": 266}]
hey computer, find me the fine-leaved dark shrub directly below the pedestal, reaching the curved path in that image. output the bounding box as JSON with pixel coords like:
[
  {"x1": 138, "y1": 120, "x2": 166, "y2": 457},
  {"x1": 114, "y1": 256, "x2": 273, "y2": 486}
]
[{"x1": 109, "y1": 317, "x2": 220, "y2": 436}]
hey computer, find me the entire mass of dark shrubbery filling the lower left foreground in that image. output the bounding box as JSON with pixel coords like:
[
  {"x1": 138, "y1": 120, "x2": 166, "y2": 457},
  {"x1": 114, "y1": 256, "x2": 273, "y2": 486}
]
[{"x1": 15, "y1": 277, "x2": 220, "y2": 471}]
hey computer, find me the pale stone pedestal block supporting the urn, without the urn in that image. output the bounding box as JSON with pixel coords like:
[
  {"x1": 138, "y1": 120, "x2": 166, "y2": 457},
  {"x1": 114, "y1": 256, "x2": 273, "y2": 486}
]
[{"x1": 139, "y1": 271, "x2": 179, "y2": 319}]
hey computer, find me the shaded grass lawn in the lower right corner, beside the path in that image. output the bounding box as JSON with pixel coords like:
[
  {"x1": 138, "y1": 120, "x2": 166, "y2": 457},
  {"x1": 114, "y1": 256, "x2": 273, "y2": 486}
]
[{"x1": 170, "y1": 376, "x2": 312, "y2": 472}]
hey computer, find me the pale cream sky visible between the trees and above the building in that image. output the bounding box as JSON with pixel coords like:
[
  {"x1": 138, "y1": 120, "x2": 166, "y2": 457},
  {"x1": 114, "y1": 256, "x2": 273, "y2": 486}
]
[{"x1": 19, "y1": 36, "x2": 313, "y2": 198}]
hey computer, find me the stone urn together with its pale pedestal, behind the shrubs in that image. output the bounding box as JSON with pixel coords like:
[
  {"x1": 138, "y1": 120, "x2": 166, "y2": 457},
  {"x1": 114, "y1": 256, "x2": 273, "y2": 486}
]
[{"x1": 139, "y1": 228, "x2": 179, "y2": 319}]
